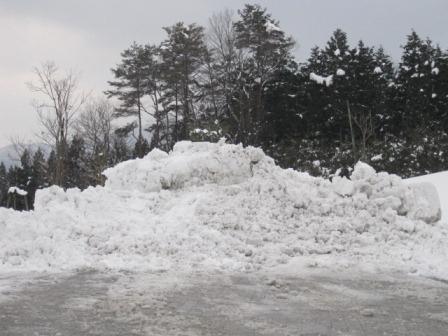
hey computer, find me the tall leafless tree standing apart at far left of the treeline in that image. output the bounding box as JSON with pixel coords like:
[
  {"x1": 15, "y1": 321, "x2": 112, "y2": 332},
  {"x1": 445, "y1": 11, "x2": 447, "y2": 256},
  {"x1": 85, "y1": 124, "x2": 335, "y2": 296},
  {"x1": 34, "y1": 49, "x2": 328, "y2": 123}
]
[{"x1": 28, "y1": 62, "x2": 85, "y2": 185}]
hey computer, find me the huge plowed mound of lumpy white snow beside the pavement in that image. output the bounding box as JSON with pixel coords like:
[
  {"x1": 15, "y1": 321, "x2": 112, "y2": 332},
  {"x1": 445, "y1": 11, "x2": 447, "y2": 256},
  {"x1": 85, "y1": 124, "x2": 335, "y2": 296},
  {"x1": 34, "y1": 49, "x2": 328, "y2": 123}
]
[{"x1": 0, "y1": 142, "x2": 448, "y2": 277}]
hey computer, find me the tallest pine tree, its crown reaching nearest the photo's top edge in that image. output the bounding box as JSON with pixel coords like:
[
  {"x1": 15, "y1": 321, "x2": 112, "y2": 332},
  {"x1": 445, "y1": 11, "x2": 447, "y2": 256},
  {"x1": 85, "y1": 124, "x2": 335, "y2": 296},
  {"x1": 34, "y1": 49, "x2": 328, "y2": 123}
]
[{"x1": 235, "y1": 5, "x2": 294, "y2": 144}]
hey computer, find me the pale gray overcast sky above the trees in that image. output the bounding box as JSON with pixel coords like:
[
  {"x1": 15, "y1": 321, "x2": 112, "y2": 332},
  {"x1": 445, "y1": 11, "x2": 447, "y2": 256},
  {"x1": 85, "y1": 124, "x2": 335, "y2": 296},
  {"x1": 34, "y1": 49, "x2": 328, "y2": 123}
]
[{"x1": 0, "y1": 0, "x2": 448, "y2": 147}]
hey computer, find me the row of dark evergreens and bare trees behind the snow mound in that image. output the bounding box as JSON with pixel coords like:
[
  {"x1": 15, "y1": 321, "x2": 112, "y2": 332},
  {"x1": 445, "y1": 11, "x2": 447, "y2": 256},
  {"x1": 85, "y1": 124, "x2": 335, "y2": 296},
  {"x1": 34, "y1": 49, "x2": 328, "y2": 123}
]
[{"x1": 0, "y1": 5, "x2": 448, "y2": 210}]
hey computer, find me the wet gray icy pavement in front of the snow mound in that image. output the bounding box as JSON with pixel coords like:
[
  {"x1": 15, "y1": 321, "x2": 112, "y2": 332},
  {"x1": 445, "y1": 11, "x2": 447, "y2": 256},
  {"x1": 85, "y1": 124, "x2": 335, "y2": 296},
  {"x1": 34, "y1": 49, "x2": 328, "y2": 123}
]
[{"x1": 0, "y1": 270, "x2": 448, "y2": 336}]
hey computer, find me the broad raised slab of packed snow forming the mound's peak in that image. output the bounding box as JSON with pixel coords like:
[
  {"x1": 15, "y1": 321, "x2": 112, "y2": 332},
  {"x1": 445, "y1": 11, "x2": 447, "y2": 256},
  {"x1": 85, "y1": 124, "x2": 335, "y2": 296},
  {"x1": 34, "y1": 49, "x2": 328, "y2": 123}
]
[{"x1": 103, "y1": 141, "x2": 271, "y2": 192}]
